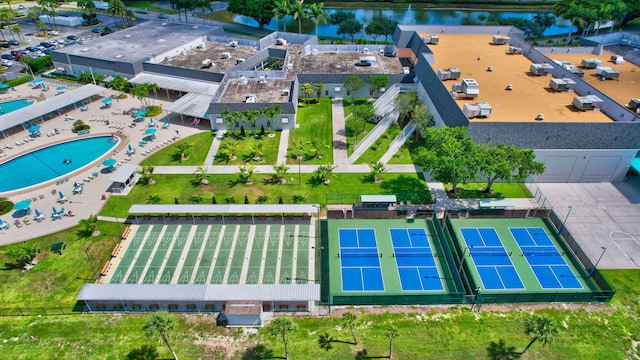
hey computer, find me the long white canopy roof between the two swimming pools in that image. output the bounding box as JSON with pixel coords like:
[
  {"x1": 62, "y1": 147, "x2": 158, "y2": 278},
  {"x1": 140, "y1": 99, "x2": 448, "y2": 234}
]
[{"x1": 0, "y1": 84, "x2": 106, "y2": 131}]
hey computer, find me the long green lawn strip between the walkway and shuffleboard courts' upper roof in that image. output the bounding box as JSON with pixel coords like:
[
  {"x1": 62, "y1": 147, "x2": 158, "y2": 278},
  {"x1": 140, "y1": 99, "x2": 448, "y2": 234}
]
[{"x1": 100, "y1": 172, "x2": 431, "y2": 218}]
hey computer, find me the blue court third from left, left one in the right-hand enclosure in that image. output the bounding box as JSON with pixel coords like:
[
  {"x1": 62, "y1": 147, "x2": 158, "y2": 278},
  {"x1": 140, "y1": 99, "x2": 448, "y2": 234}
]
[{"x1": 460, "y1": 228, "x2": 524, "y2": 290}]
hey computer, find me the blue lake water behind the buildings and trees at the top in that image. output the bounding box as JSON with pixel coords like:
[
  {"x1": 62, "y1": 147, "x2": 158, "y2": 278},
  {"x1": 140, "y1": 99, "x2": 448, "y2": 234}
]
[{"x1": 233, "y1": 8, "x2": 575, "y2": 39}]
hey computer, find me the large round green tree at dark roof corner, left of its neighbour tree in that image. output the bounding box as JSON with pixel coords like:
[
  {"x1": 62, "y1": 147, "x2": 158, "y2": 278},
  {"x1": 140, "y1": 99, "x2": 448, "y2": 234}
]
[{"x1": 414, "y1": 127, "x2": 479, "y2": 194}]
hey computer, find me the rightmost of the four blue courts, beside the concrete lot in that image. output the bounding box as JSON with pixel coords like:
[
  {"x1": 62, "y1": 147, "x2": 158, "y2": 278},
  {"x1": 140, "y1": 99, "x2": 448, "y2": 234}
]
[{"x1": 509, "y1": 227, "x2": 583, "y2": 289}]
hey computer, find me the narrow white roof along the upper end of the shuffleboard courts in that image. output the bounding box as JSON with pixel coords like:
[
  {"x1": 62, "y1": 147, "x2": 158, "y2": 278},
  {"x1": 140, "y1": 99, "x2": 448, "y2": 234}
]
[{"x1": 129, "y1": 204, "x2": 320, "y2": 214}]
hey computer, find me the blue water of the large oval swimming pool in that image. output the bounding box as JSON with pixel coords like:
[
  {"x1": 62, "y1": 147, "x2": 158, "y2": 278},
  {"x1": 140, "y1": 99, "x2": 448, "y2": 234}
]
[{"x1": 0, "y1": 136, "x2": 116, "y2": 192}]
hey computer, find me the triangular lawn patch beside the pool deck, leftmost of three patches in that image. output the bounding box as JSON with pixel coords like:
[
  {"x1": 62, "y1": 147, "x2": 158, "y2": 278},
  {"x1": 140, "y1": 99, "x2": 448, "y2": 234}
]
[{"x1": 140, "y1": 131, "x2": 214, "y2": 166}]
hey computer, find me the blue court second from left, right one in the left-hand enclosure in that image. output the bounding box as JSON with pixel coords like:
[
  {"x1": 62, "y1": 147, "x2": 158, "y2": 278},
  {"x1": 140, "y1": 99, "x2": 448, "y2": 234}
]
[{"x1": 389, "y1": 228, "x2": 444, "y2": 291}]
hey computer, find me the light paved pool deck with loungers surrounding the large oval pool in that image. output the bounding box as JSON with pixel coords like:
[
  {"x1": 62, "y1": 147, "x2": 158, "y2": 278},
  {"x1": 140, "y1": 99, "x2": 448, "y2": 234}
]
[{"x1": 0, "y1": 84, "x2": 203, "y2": 245}]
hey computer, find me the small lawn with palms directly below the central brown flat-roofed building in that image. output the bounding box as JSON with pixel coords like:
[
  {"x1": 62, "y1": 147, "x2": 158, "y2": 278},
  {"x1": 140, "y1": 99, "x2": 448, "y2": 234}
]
[{"x1": 214, "y1": 130, "x2": 280, "y2": 165}]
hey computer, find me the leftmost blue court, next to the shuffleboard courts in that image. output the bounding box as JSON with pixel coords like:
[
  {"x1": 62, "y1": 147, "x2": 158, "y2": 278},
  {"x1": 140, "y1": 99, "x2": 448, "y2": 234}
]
[{"x1": 339, "y1": 229, "x2": 384, "y2": 291}]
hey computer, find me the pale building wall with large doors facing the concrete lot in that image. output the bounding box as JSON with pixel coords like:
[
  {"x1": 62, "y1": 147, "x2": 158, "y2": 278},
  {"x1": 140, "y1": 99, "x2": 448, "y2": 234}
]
[{"x1": 534, "y1": 149, "x2": 638, "y2": 182}]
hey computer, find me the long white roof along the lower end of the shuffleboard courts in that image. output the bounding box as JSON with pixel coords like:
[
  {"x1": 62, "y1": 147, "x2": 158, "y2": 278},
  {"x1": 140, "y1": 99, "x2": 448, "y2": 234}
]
[{"x1": 76, "y1": 284, "x2": 320, "y2": 302}]
